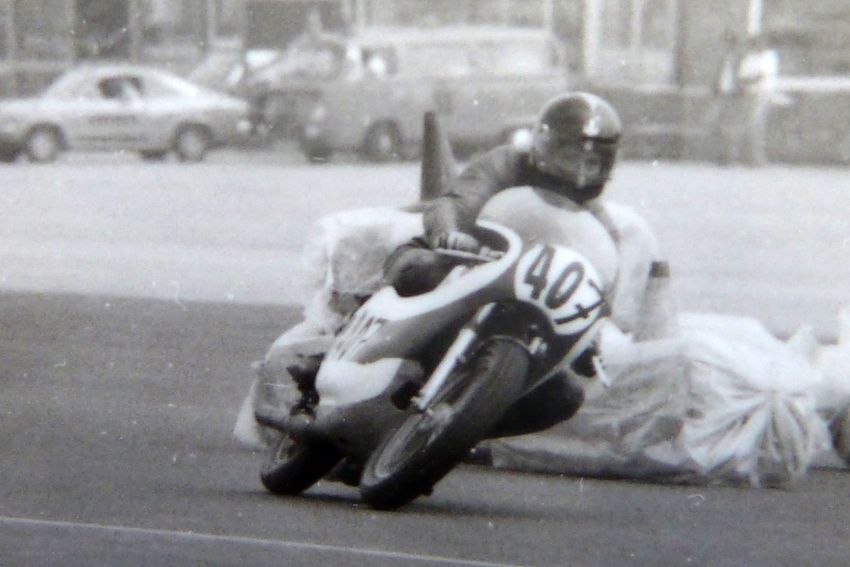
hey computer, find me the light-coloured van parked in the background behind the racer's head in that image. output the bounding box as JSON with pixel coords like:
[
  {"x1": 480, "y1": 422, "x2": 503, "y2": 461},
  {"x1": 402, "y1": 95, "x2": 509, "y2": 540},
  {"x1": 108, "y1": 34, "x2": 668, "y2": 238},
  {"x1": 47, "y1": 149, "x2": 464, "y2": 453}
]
[{"x1": 294, "y1": 26, "x2": 568, "y2": 161}]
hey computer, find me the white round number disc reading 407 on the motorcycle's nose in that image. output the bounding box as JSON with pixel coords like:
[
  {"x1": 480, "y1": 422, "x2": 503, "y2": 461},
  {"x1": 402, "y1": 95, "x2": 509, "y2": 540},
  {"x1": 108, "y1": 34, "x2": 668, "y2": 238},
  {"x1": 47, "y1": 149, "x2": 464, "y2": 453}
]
[{"x1": 514, "y1": 244, "x2": 605, "y2": 335}]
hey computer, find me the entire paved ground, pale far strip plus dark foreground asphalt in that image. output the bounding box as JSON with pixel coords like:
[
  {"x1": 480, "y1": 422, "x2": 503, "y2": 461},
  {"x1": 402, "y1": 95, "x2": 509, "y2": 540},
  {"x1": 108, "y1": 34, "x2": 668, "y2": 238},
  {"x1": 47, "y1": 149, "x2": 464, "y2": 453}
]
[{"x1": 0, "y1": 153, "x2": 850, "y2": 567}]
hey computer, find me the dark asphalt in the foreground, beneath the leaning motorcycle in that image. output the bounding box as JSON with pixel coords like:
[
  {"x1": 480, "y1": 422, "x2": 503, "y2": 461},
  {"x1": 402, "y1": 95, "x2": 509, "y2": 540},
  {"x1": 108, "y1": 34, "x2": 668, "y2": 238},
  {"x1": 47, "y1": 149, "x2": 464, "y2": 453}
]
[{"x1": 0, "y1": 292, "x2": 850, "y2": 567}]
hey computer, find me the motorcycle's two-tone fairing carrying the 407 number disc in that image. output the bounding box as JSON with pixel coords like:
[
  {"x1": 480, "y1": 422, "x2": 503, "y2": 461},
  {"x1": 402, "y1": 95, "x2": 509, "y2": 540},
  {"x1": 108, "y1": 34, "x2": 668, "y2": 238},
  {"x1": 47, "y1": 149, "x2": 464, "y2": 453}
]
[{"x1": 316, "y1": 221, "x2": 607, "y2": 412}]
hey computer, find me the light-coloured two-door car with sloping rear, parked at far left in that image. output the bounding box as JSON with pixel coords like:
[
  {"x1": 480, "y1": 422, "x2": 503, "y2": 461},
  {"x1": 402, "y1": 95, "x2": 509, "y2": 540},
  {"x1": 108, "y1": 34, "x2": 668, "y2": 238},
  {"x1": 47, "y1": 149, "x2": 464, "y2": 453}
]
[{"x1": 0, "y1": 65, "x2": 252, "y2": 162}]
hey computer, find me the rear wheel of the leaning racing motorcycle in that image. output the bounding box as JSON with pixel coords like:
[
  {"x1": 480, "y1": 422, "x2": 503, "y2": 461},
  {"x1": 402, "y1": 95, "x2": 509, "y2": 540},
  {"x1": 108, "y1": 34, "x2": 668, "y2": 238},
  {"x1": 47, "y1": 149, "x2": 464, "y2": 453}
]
[{"x1": 260, "y1": 433, "x2": 342, "y2": 494}]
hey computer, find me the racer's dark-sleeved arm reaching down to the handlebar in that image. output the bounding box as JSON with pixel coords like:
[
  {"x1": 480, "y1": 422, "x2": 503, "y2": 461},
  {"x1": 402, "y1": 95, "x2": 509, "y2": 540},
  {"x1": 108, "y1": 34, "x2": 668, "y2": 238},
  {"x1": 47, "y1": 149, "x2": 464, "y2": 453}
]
[{"x1": 424, "y1": 146, "x2": 521, "y2": 242}]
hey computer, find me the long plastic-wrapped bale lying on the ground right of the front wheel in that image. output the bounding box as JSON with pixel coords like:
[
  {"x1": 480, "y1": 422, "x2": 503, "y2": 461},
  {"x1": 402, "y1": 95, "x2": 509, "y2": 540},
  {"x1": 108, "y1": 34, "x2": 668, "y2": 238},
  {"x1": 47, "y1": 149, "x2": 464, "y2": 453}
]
[{"x1": 492, "y1": 315, "x2": 829, "y2": 486}]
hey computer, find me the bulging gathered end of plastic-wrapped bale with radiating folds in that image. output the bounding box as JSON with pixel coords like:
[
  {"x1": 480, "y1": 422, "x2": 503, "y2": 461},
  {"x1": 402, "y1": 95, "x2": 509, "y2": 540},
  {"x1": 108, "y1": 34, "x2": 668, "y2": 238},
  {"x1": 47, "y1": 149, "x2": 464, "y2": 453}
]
[{"x1": 681, "y1": 315, "x2": 829, "y2": 486}]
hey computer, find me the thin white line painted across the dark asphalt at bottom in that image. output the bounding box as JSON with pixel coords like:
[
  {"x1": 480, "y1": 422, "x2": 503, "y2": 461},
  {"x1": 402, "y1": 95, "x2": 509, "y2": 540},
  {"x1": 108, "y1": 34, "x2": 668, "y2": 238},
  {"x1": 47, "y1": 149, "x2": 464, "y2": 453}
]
[{"x1": 0, "y1": 516, "x2": 521, "y2": 567}]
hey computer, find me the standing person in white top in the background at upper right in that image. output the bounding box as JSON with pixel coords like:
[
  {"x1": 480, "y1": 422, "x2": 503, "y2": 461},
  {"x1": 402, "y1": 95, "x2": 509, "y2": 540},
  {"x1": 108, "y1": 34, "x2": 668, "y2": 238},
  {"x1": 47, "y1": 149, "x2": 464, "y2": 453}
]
[{"x1": 737, "y1": 34, "x2": 779, "y2": 166}]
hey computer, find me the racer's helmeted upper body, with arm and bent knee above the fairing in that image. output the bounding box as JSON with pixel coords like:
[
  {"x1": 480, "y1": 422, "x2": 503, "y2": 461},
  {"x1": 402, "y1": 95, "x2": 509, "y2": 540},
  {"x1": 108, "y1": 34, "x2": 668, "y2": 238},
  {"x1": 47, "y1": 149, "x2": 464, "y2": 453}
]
[{"x1": 386, "y1": 92, "x2": 622, "y2": 296}]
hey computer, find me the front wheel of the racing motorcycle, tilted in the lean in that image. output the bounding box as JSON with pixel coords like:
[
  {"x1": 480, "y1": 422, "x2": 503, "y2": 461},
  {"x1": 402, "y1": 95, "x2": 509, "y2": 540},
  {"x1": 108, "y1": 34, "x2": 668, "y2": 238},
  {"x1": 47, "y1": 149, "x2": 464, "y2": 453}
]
[{"x1": 360, "y1": 339, "x2": 529, "y2": 510}]
